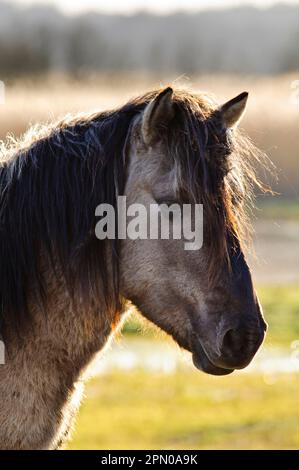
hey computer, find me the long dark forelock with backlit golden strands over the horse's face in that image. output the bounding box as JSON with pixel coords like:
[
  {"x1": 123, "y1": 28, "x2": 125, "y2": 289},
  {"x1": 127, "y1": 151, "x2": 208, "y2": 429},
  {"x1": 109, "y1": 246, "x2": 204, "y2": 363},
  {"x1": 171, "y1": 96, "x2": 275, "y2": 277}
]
[{"x1": 149, "y1": 90, "x2": 271, "y2": 284}]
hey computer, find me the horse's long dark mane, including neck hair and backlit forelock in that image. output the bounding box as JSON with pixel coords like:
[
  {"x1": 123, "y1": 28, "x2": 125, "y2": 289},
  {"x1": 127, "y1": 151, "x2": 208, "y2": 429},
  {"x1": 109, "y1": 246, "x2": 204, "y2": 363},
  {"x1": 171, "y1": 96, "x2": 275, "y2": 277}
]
[{"x1": 0, "y1": 90, "x2": 272, "y2": 327}]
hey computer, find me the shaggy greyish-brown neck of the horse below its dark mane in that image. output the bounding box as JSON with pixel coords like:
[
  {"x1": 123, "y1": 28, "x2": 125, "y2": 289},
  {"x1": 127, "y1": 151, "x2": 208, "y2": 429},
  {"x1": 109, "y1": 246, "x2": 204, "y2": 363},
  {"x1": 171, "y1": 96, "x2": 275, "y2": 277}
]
[{"x1": 0, "y1": 264, "x2": 116, "y2": 449}]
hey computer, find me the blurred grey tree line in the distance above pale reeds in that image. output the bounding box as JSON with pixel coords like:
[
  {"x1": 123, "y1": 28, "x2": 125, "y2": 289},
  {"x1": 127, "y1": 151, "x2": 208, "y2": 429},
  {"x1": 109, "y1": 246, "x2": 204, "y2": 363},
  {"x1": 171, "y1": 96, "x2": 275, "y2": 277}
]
[{"x1": 0, "y1": 2, "x2": 299, "y2": 80}]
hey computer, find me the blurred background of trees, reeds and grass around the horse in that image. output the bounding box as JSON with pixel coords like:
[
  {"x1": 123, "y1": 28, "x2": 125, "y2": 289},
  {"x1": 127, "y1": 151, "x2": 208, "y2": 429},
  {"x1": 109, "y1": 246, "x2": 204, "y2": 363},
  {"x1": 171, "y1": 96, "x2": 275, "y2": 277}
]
[{"x1": 0, "y1": 0, "x2": 299, "y2": 449}]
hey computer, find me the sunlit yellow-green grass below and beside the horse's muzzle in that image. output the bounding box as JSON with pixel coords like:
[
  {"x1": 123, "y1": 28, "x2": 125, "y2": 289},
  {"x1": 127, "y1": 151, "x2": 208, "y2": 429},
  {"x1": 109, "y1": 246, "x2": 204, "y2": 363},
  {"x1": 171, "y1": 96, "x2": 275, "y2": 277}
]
[{"x1": 69, "y1": 285, "x2": 299, "y2": 449}]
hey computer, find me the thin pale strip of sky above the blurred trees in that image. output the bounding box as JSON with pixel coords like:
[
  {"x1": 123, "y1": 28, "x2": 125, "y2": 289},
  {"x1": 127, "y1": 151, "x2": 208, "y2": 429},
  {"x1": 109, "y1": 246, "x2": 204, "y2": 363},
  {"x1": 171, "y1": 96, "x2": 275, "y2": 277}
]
[{"x1": 13, "y1": 0, "x2": 299, "y2": 14}]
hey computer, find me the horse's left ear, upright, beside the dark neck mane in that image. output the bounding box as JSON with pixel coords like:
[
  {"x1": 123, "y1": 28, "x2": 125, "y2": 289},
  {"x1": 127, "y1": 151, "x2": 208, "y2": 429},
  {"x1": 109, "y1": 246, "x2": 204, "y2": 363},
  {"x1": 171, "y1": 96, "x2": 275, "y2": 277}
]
[{"x1": 141, "y1": 87, "x2": 174, "y2": 145}]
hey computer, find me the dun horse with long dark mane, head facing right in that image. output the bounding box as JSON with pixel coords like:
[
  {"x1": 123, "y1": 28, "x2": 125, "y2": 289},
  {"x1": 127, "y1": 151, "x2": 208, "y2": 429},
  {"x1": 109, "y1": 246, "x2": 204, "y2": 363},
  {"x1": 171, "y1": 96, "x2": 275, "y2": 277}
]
[{"x1": 0, "y1": 87, "x2": 266, "y2": 449}]
